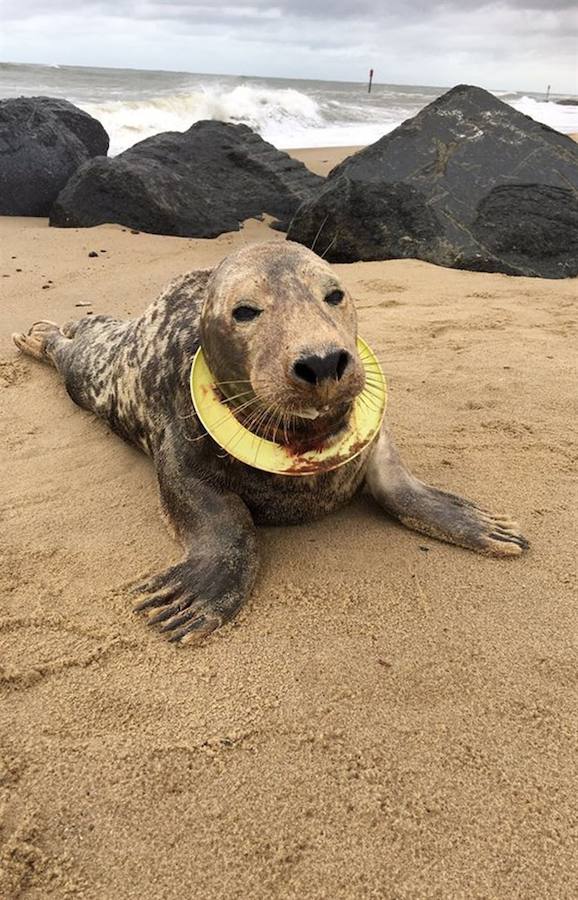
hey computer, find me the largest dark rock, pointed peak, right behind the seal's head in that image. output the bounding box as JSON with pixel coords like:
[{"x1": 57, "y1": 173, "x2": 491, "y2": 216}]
[{"x1": 288, "y1": 85, "x2": 578, "y2": 278}]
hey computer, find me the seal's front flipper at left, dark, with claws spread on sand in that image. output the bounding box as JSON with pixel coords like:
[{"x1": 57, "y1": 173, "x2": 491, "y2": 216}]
[{"x1": 135, "y1": 434, "x2": 257, "y2": 644}]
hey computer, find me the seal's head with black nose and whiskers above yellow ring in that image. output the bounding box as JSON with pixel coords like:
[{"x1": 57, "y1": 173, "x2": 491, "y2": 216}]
[{"x1": 201, "y1": 242, "x2": 365, "y2": 439}]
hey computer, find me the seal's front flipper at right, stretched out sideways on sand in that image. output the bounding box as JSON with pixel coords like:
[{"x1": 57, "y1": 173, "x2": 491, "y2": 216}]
[{"x1": 366, "y1": 427, "x2": 529, "y2": 556}]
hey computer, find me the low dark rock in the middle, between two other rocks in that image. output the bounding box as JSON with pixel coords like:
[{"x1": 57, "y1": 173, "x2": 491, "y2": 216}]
[{"x1": 50, "y1": 121, "x2": 323, "y2": 237}]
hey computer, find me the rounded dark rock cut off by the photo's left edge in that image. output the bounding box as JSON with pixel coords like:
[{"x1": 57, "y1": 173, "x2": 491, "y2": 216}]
[{"x1": 0, "y1": 97, "x2": 108, "y2": 216}]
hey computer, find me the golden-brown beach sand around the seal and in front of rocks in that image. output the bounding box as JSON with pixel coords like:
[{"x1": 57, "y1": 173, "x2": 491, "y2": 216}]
[{"x1": 0, "y1": 150, "x2": 578, "y2": 900}]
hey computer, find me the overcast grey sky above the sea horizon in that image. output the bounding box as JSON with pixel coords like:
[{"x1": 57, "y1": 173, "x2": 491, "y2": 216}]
[{"x1": 0, "y1": 0, "x2": 578, "y2": 93}]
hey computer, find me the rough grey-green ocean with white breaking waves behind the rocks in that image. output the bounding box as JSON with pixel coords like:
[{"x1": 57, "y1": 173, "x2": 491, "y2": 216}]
[{"x1": 0, "y1": 63, "x2": 578, "y2": 155}]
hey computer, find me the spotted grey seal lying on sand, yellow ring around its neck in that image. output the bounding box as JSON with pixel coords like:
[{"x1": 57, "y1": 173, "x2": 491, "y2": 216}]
[{"x1": 13, "y1": 241, "x2": 528, "y2": 643}]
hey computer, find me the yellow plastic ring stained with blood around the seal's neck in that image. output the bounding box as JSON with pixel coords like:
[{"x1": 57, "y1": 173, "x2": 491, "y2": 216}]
[{"x1": 191, "y1": 338, "x2": 387, "y2": 475}]
